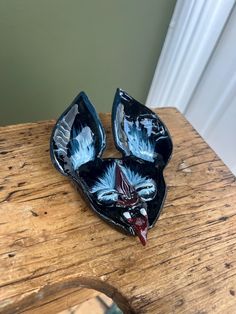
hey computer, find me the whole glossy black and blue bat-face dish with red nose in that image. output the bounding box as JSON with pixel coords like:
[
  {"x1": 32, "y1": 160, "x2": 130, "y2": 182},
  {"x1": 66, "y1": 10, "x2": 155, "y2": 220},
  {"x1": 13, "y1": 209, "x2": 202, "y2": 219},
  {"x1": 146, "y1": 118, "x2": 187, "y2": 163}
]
[{"x1": 50, "y1": 89, "x2": 173, "y2": 245}]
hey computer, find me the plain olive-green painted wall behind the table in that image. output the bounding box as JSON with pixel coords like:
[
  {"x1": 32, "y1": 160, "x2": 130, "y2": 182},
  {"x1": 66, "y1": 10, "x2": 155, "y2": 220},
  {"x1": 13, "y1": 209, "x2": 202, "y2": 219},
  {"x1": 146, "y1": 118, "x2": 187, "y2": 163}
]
[{"x1": 0, "y1": 0, "x2": 175, "y2": 125}]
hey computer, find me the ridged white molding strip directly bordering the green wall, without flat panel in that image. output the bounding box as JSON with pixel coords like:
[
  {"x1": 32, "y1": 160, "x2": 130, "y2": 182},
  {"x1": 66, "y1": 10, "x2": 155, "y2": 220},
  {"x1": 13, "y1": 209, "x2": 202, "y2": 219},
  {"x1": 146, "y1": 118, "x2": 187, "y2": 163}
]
[{"x1": 146, "y1": 0, "x2": 235, "y2": 112}]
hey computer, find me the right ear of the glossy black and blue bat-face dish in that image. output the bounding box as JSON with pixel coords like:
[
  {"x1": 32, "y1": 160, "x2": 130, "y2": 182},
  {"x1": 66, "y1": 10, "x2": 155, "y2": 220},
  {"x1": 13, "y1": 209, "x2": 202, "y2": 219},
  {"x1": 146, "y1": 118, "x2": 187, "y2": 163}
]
[{"x1": 112, "y1": 89, "x2": 172, "y2": 166}]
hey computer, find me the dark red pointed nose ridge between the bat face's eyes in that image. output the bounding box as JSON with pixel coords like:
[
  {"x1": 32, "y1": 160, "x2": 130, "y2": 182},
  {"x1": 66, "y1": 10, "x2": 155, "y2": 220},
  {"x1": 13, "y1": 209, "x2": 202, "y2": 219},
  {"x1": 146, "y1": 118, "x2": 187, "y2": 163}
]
[{"x1": 115, "y1": 164, "x2": 140, "y2": 207}]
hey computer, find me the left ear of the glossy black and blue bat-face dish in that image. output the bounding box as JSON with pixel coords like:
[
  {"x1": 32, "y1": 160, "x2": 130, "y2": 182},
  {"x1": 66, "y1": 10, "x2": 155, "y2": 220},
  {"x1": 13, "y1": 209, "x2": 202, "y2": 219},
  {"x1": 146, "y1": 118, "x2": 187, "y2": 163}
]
[{"x1": 50, "y1": 92, "x2": 106, "y2": 176}]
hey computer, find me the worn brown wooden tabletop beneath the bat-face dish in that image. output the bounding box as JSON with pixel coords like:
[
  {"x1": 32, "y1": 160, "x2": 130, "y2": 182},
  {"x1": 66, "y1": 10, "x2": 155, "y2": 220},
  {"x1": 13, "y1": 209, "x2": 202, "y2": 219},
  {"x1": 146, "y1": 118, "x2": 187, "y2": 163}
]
[{"x1": 0, "y1": 108, "x2": 236, "y2": 314}]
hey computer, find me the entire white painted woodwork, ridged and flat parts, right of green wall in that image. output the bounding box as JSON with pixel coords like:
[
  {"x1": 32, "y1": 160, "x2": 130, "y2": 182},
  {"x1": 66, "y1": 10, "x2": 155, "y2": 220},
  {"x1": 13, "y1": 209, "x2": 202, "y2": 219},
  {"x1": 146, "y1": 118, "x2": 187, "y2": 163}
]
[{"x1": 146, "y1": 0, "x2": 236, "y2": 175}]
